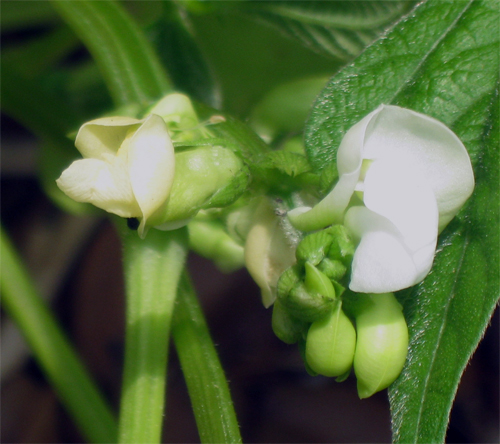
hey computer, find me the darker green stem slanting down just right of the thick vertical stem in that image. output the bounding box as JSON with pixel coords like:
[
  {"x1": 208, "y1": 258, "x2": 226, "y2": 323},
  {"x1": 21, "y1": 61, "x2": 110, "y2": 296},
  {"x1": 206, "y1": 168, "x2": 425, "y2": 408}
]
[{"x1": 172, "y1": 273, "x2": 241, "y2": 443}]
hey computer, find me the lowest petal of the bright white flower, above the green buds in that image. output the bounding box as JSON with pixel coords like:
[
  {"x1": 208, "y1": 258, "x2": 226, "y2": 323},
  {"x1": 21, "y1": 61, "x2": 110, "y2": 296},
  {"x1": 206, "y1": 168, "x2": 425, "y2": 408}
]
[{"x1": 345, "y1": 207, "x2": 424, "y2": 293}]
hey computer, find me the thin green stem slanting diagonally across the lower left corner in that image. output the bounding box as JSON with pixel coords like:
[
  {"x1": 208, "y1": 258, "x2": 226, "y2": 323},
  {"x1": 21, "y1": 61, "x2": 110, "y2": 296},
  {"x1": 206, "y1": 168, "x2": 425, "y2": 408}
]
[{"x1": 0, "y1": 229, "x2": 117, "y2": 443}]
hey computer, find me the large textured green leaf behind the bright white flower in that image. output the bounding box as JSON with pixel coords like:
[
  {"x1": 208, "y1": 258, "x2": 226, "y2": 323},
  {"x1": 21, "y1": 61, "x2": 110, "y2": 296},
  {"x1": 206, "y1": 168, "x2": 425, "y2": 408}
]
[{"x1": 306, "y1": 0, "x2": 500, "y2": 443}]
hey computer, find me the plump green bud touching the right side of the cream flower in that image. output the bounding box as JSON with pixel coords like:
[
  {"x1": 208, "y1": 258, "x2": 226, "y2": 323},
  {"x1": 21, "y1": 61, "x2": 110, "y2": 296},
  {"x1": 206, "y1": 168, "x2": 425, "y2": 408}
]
[{"x1": 148, "y1": 146, "x2": 249, "y2": 230}]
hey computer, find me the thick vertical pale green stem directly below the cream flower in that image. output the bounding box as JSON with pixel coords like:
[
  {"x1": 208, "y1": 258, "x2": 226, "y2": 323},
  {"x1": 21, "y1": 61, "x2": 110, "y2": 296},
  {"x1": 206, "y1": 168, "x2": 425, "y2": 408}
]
[{"x1": 119, "y1": 229, "x2": 187, "y2": 444}]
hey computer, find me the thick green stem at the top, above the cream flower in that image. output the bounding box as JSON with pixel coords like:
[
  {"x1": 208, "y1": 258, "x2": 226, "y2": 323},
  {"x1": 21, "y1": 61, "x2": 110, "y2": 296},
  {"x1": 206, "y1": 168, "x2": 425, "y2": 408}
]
[{"x1": 52, "y1": 0, "x2": 170, "y2": 106}]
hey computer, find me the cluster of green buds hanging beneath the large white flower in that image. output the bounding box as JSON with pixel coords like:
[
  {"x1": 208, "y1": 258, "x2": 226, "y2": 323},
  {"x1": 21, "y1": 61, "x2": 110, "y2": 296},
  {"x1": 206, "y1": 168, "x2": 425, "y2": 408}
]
[{"x1": 272, "y1": 225, "x2": 408, "y2": 398}]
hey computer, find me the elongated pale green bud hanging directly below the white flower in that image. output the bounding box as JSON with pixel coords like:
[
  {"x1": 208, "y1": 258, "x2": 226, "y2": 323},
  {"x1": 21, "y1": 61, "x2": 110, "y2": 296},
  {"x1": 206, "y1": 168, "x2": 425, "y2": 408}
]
[{"x1": 354, "y1": 293, "x2": 408, "y2": 399}]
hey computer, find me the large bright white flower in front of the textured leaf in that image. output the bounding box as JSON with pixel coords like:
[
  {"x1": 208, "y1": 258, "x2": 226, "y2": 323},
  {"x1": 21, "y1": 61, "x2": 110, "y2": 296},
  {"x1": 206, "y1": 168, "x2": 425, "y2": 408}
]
[{"x1": 289, "y1": 105, "x2": 474, "y2": 293}]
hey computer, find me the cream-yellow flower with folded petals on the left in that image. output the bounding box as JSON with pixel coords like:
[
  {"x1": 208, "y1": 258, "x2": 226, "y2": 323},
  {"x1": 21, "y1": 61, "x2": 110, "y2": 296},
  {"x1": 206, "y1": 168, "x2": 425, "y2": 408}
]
[{"x1": 57, "y1": 114, "x2": 175, "y2": 237}]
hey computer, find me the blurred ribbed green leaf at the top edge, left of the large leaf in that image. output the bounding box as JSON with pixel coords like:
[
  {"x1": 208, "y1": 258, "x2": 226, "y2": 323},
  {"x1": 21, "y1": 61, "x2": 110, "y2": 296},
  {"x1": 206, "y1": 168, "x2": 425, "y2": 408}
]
[{"x1": 244, "y1": 1, "x2": 411, "y2": 60}]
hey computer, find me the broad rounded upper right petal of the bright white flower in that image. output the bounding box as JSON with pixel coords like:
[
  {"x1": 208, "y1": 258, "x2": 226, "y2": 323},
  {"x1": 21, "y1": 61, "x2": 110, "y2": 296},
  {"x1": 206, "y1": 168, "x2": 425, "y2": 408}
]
[{"x1": 363, "y1": 105, "x2": 474, "y2": 229}]
